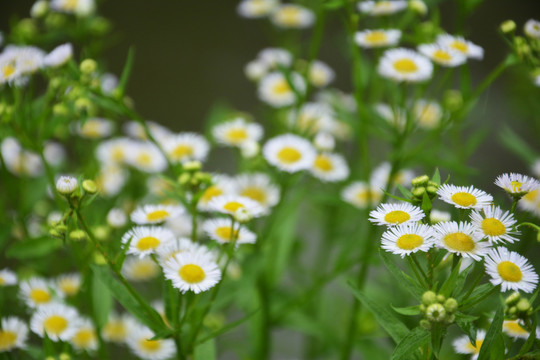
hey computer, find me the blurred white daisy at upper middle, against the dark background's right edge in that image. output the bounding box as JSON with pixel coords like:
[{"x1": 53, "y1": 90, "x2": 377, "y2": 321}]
[{"x1": 258, "y1": 71, "x2": 306, "y2": 108}]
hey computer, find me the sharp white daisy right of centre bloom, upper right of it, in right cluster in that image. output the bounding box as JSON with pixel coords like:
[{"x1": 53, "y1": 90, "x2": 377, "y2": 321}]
[{"x1": 470, "y1": 206, "x2": 519, "y2": 244}]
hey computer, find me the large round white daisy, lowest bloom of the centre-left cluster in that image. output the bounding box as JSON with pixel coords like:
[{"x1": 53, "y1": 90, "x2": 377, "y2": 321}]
[{"x1": 163, "y1": 252, "x2": 221, "y2": 294}]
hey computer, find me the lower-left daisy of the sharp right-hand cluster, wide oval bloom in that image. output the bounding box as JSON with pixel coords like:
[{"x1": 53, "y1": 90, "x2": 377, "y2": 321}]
[{"x1": 381, "y1": 223, "x2": 435, "y2": 258}]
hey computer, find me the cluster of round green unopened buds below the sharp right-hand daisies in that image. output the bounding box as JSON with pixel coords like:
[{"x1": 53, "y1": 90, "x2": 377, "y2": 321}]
[{"x1": 420, "y1": 291, "x2": 458, "y2": 329}]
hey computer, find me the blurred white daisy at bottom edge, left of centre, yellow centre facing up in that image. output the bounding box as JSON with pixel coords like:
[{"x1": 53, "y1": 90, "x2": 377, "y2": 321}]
[{"x1": 126, "y1": 322, "x2": 176, "y2": 360}]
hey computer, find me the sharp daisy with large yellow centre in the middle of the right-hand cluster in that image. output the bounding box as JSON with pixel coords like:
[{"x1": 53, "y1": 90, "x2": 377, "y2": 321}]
[{"x1": 433, "y1": 221, "x2": 489, "y2": 261}]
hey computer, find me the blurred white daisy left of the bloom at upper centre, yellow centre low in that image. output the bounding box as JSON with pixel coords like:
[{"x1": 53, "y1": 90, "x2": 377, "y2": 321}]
[{"x1": 163, "y1": 132, "x2": 210, "y2": 163}]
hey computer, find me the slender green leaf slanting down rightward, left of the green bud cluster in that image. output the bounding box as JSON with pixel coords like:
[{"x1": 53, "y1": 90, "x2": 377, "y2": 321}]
[{"x1": 347, "y1": 281, "x2": 409, "y2": 343}]
